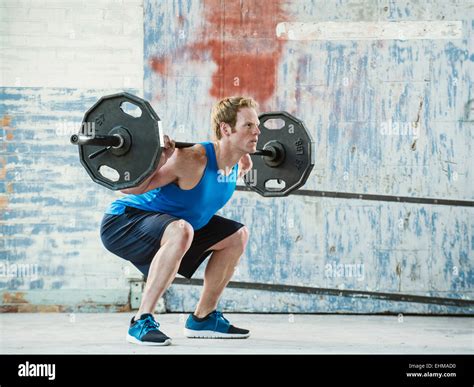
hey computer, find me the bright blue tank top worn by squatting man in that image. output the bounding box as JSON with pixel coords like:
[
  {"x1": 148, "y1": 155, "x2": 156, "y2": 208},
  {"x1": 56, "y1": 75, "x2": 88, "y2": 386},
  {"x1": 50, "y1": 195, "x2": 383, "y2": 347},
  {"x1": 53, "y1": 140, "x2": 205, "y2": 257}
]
[{"x1": 105, "y1": 142, "x2": 238, "y2": 230}]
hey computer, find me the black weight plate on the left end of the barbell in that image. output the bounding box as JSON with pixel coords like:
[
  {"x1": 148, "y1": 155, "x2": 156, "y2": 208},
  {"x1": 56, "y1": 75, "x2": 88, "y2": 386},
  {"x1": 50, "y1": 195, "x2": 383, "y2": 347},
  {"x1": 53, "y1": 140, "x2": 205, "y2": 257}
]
[{"x1": 79, "y1": 93, "x2": 161, "y2": 190}]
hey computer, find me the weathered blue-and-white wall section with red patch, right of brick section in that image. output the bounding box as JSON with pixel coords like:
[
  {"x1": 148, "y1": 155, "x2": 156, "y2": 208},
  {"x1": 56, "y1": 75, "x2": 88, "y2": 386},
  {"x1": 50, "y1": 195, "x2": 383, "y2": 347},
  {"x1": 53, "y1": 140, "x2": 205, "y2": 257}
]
[{"x1": 144, "y1": 0, "x2": 474, "y2": 313}]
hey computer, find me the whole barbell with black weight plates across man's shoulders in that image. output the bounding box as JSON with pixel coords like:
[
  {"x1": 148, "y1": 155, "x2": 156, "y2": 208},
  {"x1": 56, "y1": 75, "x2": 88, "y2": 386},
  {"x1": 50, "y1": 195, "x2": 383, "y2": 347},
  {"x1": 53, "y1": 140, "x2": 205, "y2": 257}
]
[{"x1": 71, "y1": 92, "x2": 314, "y2": 197}]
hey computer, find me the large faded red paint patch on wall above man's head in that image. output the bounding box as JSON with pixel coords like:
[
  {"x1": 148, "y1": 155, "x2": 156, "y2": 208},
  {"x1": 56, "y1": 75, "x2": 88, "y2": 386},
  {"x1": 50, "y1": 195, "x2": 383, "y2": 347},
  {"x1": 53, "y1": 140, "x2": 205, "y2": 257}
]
[{"x1": 150, "y1": 0, "x2": 286, "y2": 104}]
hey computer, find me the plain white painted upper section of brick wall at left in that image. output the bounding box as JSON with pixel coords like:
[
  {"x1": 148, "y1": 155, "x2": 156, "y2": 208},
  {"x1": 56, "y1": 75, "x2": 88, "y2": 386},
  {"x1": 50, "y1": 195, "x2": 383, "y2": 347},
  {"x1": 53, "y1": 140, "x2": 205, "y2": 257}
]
[{"x1": 0, "y1": 0, "x2": 143, "y2": 90}]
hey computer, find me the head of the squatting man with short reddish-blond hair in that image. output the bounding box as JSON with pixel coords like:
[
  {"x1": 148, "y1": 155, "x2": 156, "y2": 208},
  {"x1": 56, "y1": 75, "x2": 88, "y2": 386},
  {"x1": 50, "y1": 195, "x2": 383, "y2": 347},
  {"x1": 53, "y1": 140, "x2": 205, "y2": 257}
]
[{"x1": 211, "y1": 97, "x2": 260, "y2": 153}]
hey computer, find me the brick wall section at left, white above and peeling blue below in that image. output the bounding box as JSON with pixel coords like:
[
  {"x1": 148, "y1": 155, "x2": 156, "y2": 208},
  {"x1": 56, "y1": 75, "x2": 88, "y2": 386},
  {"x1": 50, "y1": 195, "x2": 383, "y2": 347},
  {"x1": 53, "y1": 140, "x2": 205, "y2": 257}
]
[{"x1": 0, "y1": 0, "x2": 143, "y2": 311}]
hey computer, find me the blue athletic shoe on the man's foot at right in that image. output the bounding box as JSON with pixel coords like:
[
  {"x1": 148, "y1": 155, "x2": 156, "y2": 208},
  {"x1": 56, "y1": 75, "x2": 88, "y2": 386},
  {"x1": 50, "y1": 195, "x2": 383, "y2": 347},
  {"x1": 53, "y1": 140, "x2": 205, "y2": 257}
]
[{"x1": 184, "y1": 310, "x2": 250, "y2": 339}]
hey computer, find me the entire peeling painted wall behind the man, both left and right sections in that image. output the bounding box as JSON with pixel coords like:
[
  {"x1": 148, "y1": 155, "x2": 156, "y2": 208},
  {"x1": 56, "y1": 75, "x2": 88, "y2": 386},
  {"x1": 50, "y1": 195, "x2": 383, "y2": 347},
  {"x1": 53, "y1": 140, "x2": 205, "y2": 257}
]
[{"x1": 0, "y1": 0, "x2": 474, "y2": 314}]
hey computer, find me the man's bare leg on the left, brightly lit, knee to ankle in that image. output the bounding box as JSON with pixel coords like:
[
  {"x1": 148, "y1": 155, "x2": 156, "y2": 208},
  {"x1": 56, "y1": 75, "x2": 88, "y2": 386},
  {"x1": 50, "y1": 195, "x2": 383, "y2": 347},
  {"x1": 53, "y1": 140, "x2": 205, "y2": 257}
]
[{"x1": 135, "y1": 220, "x2": 194, "y2": 320}]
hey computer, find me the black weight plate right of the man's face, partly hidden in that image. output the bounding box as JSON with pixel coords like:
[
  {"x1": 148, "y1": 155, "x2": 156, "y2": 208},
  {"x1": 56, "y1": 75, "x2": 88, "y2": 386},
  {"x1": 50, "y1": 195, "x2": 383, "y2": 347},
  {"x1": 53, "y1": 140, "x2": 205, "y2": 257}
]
[{"x1": 244, "y1": 112, "x2": 315, "y2": 197}]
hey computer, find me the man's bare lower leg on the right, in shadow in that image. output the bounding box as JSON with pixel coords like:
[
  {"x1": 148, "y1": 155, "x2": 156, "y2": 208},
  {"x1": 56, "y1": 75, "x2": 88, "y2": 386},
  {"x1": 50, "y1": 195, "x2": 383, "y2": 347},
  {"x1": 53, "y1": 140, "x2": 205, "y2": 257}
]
[{"x1": 194, "y1": 226, "x2": 249, "y2": 318}]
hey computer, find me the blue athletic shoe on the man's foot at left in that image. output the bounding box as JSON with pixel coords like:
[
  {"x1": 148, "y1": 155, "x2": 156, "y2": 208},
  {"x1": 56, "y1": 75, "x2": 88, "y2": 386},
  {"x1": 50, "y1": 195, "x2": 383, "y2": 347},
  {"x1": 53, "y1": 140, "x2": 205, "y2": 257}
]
[{"x1": 127, "y1": 313, "x2": 171, "y2": 345}]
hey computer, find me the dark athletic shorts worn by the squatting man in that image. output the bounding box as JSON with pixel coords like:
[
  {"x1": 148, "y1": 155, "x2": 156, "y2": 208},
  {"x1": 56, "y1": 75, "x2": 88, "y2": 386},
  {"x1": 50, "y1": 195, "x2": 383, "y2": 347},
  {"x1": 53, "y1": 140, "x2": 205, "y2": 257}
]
[{"x1": 100, "y1": 207, "x2": 243, "y2": 278}]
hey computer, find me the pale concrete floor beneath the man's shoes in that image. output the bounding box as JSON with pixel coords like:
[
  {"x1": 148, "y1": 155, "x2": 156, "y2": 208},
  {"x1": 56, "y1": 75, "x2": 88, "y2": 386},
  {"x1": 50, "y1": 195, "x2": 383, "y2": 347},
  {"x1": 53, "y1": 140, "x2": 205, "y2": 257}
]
[{"x1": 0, "y1": 313, "x2": 474, "y2": 354}]
